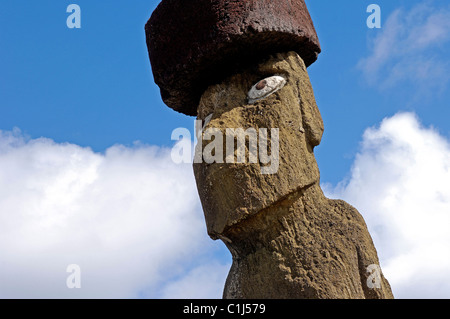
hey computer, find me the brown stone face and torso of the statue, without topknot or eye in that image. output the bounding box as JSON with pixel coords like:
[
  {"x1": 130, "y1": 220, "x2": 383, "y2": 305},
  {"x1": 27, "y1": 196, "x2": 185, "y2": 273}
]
[{"x1": 194, "y1": 52, "x2": 393, "y2": 298}]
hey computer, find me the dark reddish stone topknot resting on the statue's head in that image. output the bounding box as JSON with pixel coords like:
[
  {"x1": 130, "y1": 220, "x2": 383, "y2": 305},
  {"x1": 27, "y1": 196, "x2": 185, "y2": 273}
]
[{"x1": 145, "y1": 0, "x2": 321, "y2": 116}]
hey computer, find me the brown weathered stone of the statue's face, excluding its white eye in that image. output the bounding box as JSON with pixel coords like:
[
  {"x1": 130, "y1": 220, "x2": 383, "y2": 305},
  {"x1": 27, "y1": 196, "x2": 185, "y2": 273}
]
[{"x1": 195, "y1": 53, "x2": 324, "y2": 237}]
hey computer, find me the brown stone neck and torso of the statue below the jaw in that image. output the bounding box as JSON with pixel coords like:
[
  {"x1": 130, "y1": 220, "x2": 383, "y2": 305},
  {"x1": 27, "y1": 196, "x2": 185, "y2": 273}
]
[{"x1": 224, "y1": 184, "x2": 393, "y2": 299}]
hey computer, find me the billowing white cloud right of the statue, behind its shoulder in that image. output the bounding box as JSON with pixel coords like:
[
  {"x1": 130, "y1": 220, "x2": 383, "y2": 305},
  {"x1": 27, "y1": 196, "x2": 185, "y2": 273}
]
[{"x1": 324, "y1": 113, "x2": 450, "y2": 298}]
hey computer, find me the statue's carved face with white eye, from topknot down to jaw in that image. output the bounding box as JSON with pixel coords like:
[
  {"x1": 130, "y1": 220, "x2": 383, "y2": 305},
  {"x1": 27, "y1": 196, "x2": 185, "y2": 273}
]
[{"x1": 194, "y1": 52, "x2": 323, "y2": 239}]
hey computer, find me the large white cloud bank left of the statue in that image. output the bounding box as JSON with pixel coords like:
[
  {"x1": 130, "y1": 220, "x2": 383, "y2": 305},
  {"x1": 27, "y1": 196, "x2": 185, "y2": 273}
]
[{"x1": 0, "y1": 130, "x2": 228, "y2": 298}]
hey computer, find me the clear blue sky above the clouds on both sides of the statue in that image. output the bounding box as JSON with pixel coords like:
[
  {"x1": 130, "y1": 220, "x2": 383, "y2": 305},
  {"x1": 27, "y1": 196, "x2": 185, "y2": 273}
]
[{"x1": 0, "y1": 0, "x2": 450, "y2": 182}]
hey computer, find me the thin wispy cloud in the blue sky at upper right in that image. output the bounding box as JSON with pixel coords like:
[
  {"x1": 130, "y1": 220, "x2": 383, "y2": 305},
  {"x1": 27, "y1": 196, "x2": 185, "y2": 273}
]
[{"x1": 358, "y1": 1, "x2": 450, "y2": 91}]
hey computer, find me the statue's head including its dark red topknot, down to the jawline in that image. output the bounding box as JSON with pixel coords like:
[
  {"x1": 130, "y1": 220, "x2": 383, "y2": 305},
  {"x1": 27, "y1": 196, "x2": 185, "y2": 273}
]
[{"x1": 145, "y1": 0, "x2": 323, "y2": 238}]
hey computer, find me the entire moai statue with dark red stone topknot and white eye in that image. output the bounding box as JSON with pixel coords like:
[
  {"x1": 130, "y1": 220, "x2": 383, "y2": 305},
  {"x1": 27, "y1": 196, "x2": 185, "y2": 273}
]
[{"x1": 146, "y1": 0, "x2": 393, "y2": 299}]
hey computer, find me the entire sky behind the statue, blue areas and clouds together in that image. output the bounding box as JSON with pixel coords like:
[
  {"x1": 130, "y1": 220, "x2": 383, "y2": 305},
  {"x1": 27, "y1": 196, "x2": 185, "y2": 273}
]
[{"x1": 0, "y1": 0, "x2": 450, "y2": 298}]
